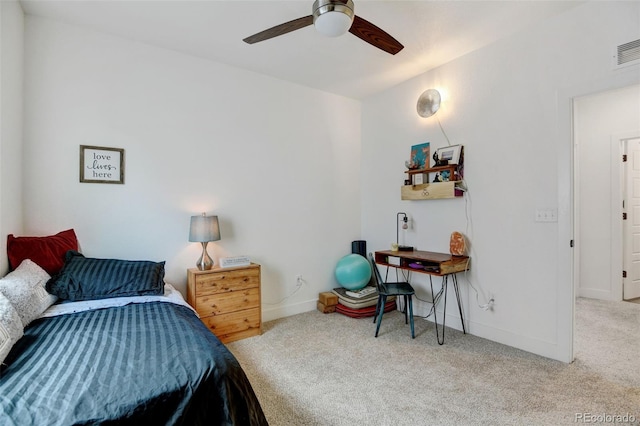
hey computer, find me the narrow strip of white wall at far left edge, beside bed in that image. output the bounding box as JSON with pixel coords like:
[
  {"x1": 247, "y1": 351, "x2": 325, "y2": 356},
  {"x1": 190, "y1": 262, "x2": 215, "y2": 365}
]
[{"x1": 0, "y1": 0, "x2": 24, "y2": 276}]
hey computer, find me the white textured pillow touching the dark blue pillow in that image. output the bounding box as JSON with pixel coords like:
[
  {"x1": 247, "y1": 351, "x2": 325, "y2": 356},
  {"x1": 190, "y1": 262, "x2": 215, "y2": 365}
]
[{"x1": 0, "y1": 259, "x2": 57, "y2": 327}]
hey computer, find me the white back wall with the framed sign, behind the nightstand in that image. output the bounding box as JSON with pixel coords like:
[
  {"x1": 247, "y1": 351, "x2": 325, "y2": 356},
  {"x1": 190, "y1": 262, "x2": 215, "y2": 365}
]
[{"x1": 24, "y1": 16, "x2": 361, "y2": 320}]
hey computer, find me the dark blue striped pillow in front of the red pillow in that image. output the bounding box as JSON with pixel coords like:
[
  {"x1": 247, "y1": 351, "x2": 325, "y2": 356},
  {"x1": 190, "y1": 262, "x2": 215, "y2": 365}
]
[{"x1": 47, "y1": 251, "x2": 164, "y2": 300}]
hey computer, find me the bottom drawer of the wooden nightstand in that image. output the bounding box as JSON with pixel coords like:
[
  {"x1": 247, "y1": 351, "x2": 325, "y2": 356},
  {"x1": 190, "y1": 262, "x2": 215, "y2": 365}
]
[{"x1": 201, "y1": 308, "x2": 262, "y2": 343}]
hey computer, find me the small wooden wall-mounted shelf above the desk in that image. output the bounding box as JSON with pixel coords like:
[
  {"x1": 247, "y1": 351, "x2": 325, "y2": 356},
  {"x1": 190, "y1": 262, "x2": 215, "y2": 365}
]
[{"x1": 400, "y1": 164, "x2": 462, "y2": 200}]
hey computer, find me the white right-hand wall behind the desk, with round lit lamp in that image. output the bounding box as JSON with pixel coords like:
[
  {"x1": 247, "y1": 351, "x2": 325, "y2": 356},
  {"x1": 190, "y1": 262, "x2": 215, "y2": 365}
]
[{"x1": 362, "y1": 2, "x2": 640, "y2": 361}]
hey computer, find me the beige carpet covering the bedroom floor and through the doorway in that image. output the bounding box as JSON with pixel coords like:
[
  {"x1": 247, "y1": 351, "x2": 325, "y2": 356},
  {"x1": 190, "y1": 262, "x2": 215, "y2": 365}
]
[{"x1": 228, "y1": 299, "x2": 640, "y2": 426}]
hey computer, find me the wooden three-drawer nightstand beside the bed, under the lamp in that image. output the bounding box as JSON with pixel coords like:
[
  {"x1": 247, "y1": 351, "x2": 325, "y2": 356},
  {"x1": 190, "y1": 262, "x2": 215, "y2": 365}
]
[{"x1": 187, "y1": 263, "x2": 262, "y2": 343}]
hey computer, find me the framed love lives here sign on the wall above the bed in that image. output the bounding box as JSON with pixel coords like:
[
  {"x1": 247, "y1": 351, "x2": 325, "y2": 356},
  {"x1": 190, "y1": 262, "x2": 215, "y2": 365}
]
[{"x1": 80, "y1": 145, "x2": 124, "y2": 184}]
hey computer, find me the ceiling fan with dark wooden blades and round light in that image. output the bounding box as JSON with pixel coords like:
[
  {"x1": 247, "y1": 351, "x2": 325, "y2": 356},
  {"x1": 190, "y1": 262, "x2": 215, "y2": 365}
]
[{"x1": 243, "y1": 0, "x2": 404, "y2": 55}]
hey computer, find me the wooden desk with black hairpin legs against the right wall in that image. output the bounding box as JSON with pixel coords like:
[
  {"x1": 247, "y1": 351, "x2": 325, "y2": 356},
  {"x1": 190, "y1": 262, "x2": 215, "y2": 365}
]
[{"x1": 374, "y1": 250, "x2": 471, "y2": 345}]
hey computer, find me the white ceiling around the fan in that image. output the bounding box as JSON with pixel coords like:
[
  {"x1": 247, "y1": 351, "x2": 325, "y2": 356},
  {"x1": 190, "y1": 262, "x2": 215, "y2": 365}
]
[{"x1": 20, "y1": 0, "x2": 582, "y2": 99}]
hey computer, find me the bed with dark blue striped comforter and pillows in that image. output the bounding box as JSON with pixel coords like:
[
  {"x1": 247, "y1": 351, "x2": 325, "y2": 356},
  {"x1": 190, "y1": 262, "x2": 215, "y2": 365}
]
[{"x1": 0, "y1": 231, "x2": 267, "y2": 425}]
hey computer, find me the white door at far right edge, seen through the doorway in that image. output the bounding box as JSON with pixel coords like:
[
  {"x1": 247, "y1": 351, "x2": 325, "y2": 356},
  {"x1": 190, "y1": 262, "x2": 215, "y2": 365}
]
[{"x1": 622, "y1": 138, "x2": 640, "y2": 300}]
